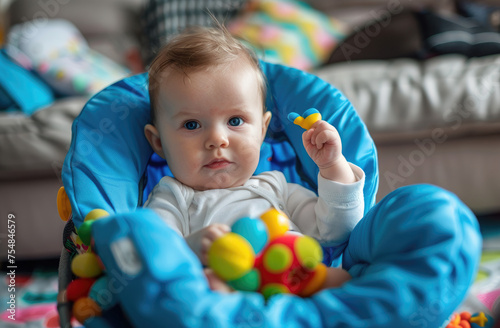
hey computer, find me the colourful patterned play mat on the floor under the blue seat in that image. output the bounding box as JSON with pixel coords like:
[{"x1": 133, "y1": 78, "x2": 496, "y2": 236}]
[{"x1": 0, "y1": 218, "x2": 500, "y2": 328}]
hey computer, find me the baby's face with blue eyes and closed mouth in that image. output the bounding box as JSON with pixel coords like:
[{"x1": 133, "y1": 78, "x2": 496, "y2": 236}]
[{"x1": 153, "y1": 61, "x2": 271, "y2": 190}]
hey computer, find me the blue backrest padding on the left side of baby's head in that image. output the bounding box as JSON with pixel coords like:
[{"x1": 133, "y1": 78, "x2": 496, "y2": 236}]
[{"x1": 62, "y1": 74, "x2": 152, "y2": 227}]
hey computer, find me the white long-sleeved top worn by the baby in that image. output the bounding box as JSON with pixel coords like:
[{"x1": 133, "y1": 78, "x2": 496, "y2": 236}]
[{"x1": 144, "y1": 164, "x2": 365, "y2": 246}]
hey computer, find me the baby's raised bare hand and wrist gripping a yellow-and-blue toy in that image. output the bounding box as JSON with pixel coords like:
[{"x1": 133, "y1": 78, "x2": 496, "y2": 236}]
[{"x1": 302, "y1": 120, "x2": 357, "y2": 183}]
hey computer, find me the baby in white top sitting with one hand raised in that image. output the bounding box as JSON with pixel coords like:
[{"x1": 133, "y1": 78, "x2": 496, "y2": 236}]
[{"x1": 144, "y1": 26, "x2": 364, "y2": 289}]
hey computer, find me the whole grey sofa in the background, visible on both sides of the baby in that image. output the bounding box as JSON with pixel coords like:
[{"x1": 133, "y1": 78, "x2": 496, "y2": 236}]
[{"x1": 0, "y1": 0, "x2": 500, "y2": 260}]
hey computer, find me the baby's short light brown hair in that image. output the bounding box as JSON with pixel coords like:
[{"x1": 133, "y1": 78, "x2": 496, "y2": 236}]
[{"x1": 149, "y1": 21, "x2": 267, "y2": 124}]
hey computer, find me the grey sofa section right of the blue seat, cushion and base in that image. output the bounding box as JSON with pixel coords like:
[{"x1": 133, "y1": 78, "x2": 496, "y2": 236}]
[{"x1": 316, "y1": 55, "x2": 500, "y2": 214}]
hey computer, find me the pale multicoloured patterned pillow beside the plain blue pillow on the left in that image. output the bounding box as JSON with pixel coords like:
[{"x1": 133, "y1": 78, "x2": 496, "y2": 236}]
[{"x1": 6, "y1": 19, "x2": 129, "y2": 97}]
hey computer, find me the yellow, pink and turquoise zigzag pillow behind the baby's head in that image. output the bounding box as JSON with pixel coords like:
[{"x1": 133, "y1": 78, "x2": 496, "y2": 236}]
[{"x1": 228, "y1": 0, "x2": 346, "y2": 70}]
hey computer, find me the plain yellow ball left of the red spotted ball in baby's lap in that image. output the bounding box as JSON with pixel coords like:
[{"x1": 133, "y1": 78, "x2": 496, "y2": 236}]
[{"x1": 208, "y1": 232, "x2": 255, "y2": 281}]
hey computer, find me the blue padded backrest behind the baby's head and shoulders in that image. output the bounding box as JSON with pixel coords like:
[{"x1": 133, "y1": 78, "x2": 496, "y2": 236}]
[{"x1": 62, "y1": 62, "x2": 378, "y2": 227}]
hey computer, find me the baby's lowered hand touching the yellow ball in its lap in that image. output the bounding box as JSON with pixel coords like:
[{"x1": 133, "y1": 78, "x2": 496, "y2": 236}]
[{"x1": 186, "y1": 223, "x2": 231, "y2": 265}]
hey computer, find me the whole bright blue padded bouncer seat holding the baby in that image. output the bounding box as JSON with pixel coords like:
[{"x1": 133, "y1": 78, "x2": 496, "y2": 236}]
[{"x1": 60, "y1": 62, "x2": 481, "y2": 328}]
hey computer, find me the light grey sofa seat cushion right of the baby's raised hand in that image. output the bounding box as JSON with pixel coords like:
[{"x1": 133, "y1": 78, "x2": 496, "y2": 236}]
[{"x1": 314, "y1": 55, "x2": 500, "y2": 145}]
